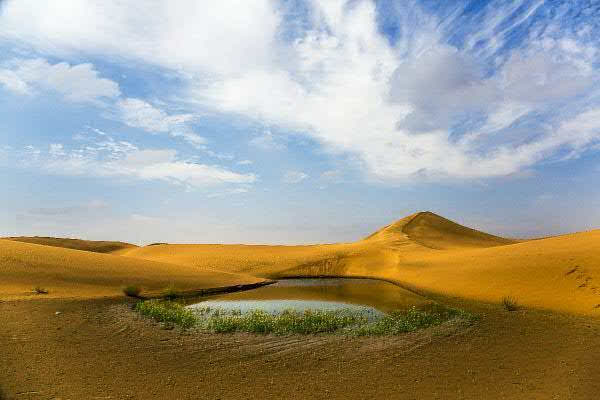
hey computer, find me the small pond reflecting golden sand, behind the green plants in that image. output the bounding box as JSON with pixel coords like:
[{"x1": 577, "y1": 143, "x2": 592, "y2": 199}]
[{"x1": 188, "y1": 278, "x2": 430, "y2": 317}]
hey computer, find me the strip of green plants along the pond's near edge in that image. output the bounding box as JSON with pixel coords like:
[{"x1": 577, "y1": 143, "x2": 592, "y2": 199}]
[{"x1": 135, "y1": 300, "x2": 475, "y2": 336}]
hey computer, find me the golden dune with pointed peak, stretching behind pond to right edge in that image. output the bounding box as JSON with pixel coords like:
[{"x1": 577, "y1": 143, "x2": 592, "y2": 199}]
[{"x1": 120, "y1": 212, "x2": 600, "y2": 316}]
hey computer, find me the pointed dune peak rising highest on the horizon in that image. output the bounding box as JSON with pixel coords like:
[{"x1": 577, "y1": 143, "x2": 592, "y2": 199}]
[{"x1": 367, "y1": 211, "x2": 516, "y2": 250}]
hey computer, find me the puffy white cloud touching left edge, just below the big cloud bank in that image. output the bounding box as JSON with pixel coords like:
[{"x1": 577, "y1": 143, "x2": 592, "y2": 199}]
[{"x1": 0, "y1": 58, "x2": 120, "y2": 102}]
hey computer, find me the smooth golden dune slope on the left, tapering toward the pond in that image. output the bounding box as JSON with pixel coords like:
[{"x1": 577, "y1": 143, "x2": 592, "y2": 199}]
[{"x1": 0, "y1": 240, "x2": 262, "y2": 299}]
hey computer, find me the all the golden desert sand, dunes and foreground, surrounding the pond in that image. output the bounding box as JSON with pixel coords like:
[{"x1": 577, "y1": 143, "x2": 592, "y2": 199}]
[{"x1": 0, "y1": 212, "x2": 600, "y2": 400}]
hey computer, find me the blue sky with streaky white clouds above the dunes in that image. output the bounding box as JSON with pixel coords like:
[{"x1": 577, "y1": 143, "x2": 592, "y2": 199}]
[{"x1": 0, "y1": 0, "x2": 600, "y2": 244}]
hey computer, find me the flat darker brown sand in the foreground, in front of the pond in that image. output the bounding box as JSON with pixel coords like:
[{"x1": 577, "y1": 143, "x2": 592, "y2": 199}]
[{"x1": 0, "y1": 299, "x2": 600, "y2": 400}]
